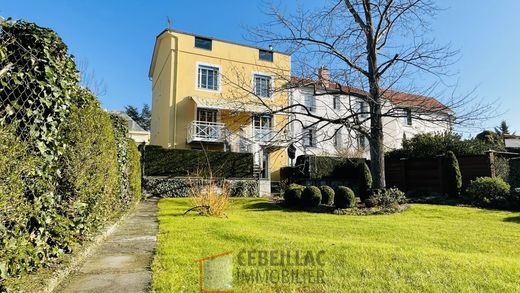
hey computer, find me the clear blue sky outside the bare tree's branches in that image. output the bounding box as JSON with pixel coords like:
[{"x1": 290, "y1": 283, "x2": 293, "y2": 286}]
[{"x1": 0, "y1": 0, "x2": 520, "y2": 132}]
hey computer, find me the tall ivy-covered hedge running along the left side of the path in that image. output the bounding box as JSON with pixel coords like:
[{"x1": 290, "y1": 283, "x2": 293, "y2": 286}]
[{"x1": 0, "y1": 21, "x2": 140, "y2": 292}]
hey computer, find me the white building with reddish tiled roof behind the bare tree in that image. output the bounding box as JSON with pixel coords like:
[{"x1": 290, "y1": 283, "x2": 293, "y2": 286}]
[{"x1": 288, "y1": 67, "x2": 454, "y2": 158}]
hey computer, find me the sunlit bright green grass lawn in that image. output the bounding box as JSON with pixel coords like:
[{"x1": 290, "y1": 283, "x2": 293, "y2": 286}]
[{"x1": 153, "y1": 199, "x2": 520, "y2": 292}]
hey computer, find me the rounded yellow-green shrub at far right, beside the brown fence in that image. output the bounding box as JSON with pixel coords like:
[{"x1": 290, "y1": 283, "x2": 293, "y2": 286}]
[{"x1": 467, "y1": 177, "x2": 511, "y2": 208}]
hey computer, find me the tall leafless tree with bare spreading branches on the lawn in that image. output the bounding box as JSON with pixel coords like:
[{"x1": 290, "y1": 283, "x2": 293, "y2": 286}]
[{"x1": 246, "y1": 0, "x2": 490, "y2": 188}]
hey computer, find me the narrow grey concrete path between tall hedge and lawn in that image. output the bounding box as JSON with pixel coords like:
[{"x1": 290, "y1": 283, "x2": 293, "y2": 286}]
[{"x1": 56, "y1": 199, "x2": 158, "y2": 292}]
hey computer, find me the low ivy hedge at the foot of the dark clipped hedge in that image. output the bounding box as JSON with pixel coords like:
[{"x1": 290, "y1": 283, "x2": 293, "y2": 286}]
[{"x1": 143, "y1": 177, "x2": 260, "y2": 198}]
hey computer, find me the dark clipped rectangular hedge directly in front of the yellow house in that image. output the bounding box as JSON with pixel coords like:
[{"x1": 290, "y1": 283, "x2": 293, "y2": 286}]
[{"x1": 144, "y1": 146, "x2": 253, "y2": 178}]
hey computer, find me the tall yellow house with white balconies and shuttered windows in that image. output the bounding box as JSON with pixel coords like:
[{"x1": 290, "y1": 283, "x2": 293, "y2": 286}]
[{"x1": 149, "y1": 29, "x2": 291, "y2": 180}]
